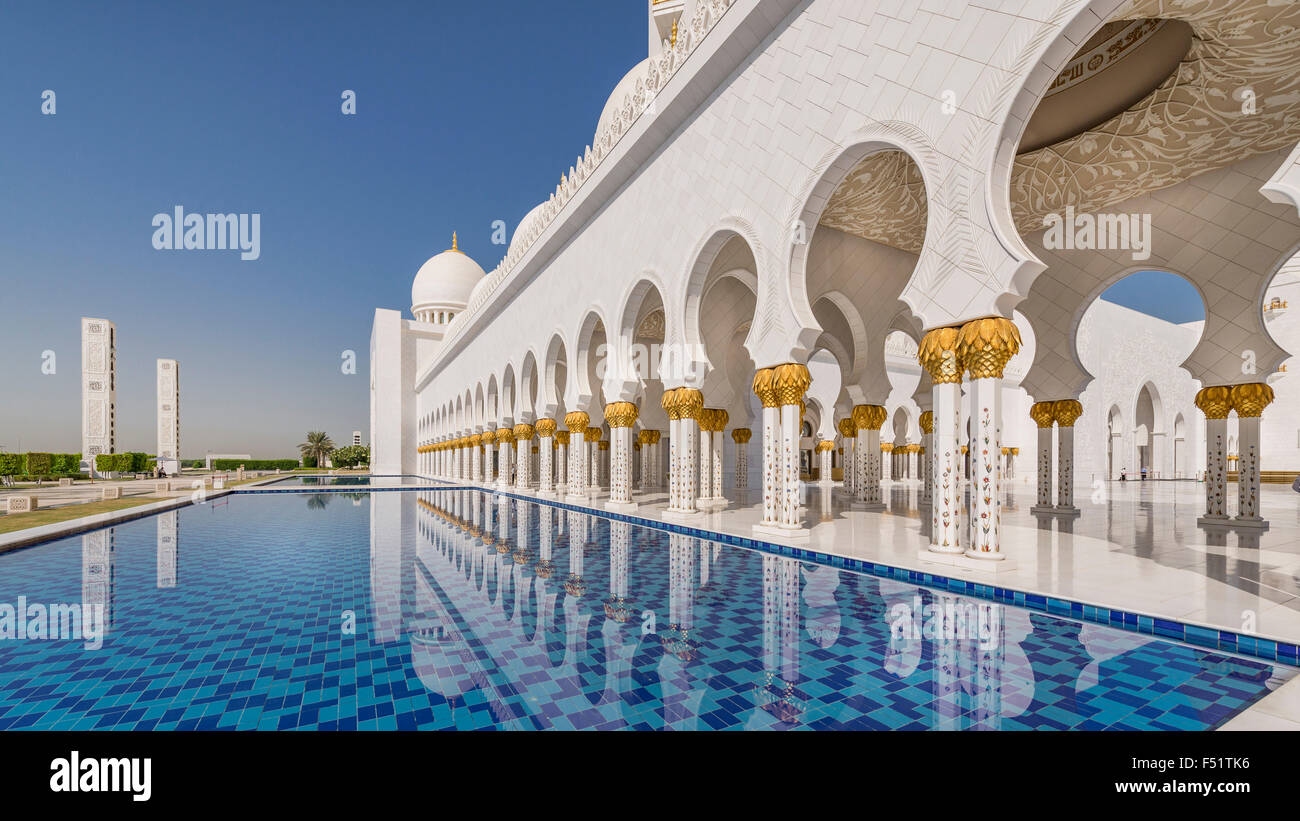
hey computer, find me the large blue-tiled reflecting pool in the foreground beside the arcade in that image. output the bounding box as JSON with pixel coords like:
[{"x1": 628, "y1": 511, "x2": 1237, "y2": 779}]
[{"x1": 0, "y1": 490, "x2": 1296, "y2": 730}]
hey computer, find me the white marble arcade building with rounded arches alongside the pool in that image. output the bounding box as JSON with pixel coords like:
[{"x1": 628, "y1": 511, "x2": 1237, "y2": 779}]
[{"x1": 371, "y1": 0, "x2": 1300, "y2": 543}]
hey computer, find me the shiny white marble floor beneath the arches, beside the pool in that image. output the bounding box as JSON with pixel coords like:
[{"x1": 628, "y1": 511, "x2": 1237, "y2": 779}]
[{"x1": 564, "y1": 481, "x2": 1300, "y2": 642}]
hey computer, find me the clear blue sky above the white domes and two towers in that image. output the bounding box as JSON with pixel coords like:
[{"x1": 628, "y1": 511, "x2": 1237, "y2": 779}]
[{"x1": 0, "y1": 0, "x2": 1199, "y2": 457}]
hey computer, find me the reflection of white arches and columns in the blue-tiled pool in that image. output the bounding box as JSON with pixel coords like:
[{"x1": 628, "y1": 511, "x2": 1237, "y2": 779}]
[{"x1": 387, "y1": 490, "x2": 1294, "y2": 730}]
